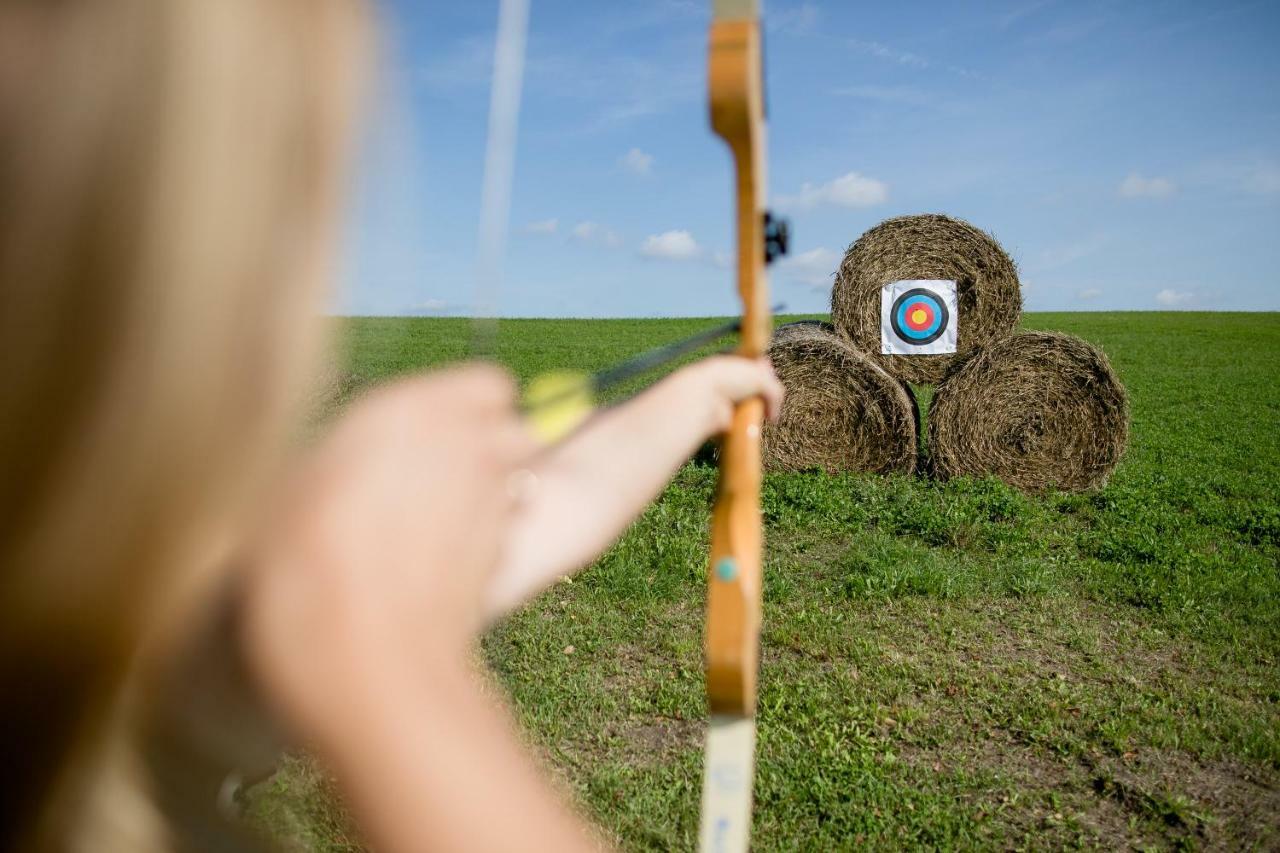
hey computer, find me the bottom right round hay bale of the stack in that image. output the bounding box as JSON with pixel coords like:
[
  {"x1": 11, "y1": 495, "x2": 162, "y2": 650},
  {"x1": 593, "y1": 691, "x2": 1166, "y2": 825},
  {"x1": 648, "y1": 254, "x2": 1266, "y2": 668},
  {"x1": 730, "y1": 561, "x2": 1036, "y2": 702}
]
[{"x1": 929, "y1": 332, "x2": 1129, "y2": 492}]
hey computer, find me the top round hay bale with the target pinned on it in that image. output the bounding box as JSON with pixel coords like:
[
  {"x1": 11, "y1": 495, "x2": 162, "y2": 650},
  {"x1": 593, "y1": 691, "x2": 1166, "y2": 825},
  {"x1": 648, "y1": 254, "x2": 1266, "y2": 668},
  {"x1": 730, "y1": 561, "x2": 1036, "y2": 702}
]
[{"x1": 831, "y1": 214, "x2": 1023, "y2": 383}]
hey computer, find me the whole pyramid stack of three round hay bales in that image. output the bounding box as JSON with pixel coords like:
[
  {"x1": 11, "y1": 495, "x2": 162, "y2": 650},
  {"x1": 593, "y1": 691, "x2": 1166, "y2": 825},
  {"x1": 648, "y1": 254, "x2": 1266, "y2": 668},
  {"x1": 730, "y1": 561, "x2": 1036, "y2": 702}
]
[{"x1": 764, "y1": 214, "x2": 1129, "y2": 492}]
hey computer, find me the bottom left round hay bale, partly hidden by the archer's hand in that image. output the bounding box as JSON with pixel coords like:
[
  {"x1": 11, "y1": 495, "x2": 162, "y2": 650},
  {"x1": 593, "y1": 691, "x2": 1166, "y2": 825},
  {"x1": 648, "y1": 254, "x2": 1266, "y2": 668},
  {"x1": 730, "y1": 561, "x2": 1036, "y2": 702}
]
[{"x1": 763, "y1": 323, "x2": 918, "y2": 474}]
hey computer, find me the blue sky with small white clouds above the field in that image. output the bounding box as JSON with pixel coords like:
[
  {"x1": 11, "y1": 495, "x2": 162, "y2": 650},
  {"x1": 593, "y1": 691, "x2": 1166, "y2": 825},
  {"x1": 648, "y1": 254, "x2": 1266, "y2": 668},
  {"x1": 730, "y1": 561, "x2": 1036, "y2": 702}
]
[{"x1": 339, "y1": 0, "x2": 1280, "y2": 316}]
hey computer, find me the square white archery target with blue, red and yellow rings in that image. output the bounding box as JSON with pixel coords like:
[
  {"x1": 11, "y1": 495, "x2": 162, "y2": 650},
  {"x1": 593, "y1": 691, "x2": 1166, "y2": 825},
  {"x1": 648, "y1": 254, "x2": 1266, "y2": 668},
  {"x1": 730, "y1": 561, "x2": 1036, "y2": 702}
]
[{"x1": 881, "y1": 279, "x2": 956, "y2": 355}]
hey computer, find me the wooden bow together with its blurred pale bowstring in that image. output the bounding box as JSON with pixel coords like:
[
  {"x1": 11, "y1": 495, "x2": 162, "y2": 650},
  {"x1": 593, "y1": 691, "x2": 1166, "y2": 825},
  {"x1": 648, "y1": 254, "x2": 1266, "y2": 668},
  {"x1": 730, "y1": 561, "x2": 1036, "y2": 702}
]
[{"x1": 476, "y1": 0, "x2": 787, "y2": 853}]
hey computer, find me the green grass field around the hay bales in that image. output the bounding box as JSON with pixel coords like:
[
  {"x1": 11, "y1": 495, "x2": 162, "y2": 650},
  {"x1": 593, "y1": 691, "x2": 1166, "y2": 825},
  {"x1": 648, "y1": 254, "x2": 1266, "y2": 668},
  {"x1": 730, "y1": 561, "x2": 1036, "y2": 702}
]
[{"x1": 248, "y1": 314, "x2": 1280, "y2": 850}]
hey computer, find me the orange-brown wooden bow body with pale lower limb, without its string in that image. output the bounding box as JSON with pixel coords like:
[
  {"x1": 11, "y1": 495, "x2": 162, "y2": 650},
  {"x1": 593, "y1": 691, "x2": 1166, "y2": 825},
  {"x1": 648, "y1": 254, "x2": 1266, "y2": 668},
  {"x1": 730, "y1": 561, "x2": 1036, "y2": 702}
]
[{"x1": 699, "y1": 0, "x2": 781, "y2": 853}]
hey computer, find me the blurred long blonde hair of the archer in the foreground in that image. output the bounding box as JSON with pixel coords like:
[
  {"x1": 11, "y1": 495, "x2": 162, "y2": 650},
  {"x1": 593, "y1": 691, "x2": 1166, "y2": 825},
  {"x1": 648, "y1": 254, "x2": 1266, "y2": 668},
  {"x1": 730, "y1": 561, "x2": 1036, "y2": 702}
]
[{"x1": 0, "y1": 0, "x2": 370, "y2": 850}]
